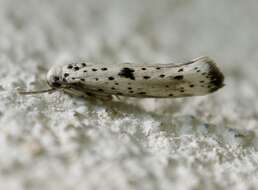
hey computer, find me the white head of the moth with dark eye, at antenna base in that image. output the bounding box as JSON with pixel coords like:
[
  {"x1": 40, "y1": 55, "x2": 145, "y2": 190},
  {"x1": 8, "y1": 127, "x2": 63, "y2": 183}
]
[{"x1": 47, "y1": 67, "x2": 64, "y2": 89}]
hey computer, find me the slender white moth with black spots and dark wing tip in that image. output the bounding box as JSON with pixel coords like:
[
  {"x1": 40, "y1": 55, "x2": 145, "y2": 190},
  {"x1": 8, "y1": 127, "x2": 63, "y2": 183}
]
[{"x1": 20, "y1": 57, "x2": 224, "y2": 99}]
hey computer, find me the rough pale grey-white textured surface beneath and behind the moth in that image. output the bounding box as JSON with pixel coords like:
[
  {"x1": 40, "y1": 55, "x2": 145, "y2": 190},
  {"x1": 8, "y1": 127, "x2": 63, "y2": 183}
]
[{"x1": 0, "y1": 0, "x2": 258, "y2": 190}]
